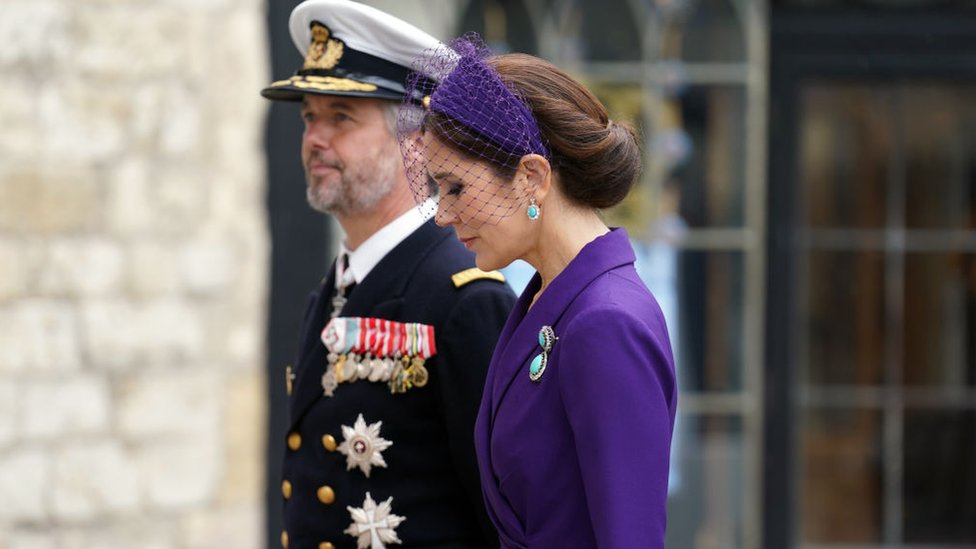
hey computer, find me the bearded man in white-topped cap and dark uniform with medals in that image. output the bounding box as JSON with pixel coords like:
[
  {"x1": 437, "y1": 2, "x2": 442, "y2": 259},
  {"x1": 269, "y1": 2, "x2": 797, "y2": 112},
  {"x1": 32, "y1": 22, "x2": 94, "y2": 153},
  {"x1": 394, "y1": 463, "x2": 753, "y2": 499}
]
[{"x1": 262, "y1": 0, "x2": 514, "y2": 549}]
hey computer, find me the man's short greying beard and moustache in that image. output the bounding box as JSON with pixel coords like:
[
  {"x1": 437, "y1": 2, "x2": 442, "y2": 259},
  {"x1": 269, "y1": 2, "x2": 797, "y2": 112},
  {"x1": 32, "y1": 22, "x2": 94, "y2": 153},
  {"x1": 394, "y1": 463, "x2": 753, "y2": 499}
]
[{"x1": 305, "y1": 147, "x2": 400, "y2": 216}]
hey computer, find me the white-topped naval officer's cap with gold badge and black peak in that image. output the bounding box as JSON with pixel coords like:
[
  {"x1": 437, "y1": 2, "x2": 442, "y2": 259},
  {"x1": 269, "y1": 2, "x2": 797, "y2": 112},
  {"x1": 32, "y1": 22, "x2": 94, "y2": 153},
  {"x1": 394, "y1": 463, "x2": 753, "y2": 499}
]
[{"x1": 261, "y1": 0, "x2": 440, "y2": 101}]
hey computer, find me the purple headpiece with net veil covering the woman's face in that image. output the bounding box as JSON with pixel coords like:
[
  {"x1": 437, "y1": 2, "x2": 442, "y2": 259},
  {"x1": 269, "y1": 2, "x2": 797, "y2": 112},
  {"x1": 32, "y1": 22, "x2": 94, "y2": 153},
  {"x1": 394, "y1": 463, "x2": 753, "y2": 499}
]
[{"x1": 397, "y1": 33, "x2": 549, "y2": 228}]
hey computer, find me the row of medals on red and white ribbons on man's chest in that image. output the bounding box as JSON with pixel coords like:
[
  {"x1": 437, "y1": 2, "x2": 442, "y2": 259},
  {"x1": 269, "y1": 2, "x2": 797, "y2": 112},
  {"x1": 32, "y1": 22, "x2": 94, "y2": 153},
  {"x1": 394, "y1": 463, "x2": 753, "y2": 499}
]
[{"x1": 321, "y1": 317, "x2": 437, "y2": 396}]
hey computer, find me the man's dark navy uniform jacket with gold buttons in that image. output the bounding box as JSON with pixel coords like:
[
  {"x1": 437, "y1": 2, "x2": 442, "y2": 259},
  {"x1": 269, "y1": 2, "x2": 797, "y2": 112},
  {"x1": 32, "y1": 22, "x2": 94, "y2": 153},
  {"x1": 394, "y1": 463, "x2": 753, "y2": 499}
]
[{"x1": 282, "y1": 221, "x2": 515, "y2": 549}]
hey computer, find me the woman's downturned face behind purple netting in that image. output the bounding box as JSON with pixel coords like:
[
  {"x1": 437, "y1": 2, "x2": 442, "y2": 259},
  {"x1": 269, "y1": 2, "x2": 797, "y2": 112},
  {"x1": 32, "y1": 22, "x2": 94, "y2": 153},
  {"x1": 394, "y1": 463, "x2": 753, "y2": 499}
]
[{"x1": 424, "y1": 133, "x2": 531, "y2": 271}]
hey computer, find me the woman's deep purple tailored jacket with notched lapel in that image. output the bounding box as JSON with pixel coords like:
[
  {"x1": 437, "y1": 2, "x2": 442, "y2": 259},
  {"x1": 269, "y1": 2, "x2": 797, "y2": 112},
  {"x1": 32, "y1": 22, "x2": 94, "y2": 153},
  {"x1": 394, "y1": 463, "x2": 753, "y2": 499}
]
[{"x1": 475, "y1": 225, "x2": 677, "y2": 549}]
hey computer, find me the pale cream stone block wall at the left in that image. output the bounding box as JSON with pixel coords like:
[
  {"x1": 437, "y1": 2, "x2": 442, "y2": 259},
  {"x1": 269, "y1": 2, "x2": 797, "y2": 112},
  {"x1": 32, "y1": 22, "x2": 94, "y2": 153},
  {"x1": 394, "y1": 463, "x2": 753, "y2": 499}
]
[{"x1": 0, "y1": 0, "x2": 270, "y2": 549}]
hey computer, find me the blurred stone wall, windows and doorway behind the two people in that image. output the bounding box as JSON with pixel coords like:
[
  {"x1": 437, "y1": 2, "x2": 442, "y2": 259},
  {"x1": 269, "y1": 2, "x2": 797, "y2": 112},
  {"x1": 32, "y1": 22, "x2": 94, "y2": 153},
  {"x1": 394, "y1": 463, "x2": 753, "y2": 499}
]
[{"x1": 0, "y1": 0, "x2": 976, "y2": 549}]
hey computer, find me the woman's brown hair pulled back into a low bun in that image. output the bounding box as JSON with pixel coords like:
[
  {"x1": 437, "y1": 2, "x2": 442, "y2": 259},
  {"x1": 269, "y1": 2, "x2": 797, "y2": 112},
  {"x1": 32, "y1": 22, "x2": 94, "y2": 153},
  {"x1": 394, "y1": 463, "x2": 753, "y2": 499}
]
[{"x1": 425, "y1": 53, "x2": 641, "y2": 209}]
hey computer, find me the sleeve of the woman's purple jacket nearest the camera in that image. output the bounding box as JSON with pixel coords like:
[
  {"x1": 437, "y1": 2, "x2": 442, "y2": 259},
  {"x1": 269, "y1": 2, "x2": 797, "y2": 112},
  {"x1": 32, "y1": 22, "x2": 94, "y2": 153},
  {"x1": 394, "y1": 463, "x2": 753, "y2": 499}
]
[{"x1": 553, "y1": 308, "x2": 675, "y2": 549}]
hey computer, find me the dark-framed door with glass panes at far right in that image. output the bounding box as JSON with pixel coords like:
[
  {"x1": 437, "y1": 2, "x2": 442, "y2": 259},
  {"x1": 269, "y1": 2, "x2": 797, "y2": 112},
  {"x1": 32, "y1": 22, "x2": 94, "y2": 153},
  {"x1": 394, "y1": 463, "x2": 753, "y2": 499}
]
[{"x1": 763, "y1": 8, "x2": 976, "y2": 549}]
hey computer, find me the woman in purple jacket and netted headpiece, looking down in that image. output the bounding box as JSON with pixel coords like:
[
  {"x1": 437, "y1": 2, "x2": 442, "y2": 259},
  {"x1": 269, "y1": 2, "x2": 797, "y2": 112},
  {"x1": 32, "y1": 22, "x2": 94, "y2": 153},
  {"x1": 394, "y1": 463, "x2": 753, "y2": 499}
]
[{"x1": 399, "y1": 36, "x2": 677, "y2": 549}]
